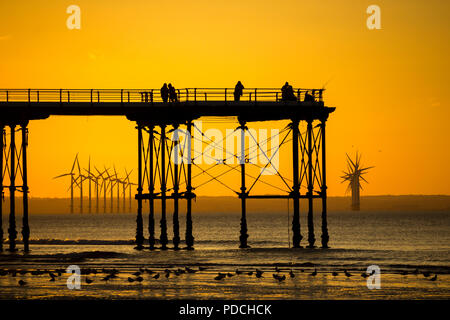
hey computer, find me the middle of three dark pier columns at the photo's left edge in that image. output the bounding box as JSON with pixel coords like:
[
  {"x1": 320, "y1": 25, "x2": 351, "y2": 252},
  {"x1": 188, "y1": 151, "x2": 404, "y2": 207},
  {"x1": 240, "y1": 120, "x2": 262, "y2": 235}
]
[{"x1": 8, "y1": 124, "x2": 17, "y2": 251}]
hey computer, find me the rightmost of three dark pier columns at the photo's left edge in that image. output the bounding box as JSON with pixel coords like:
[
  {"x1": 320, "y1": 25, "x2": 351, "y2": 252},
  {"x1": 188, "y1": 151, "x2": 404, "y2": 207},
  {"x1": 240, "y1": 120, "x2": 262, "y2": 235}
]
[{"x1": 21, "y1": 123, "x2": 30, "y2": 252}]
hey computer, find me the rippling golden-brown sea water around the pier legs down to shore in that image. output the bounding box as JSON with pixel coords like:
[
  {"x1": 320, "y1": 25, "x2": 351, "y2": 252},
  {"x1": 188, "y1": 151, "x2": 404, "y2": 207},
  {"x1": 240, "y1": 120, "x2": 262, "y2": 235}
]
[{"x1": 0, "y1": 212, "x2": 450, "y2": 299}]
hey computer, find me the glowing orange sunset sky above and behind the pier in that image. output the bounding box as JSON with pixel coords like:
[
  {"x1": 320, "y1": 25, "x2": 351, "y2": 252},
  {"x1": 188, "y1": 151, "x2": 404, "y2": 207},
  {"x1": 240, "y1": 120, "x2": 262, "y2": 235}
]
[{"x1": 0, "y1": 0, "x2": 450, "y2": 197}]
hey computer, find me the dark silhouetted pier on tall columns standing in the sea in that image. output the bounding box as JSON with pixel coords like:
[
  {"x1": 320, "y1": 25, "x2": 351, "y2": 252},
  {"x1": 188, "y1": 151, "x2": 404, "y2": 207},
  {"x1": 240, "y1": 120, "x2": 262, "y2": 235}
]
[{"x1": 0, "y1": 88, "x2": 335, "y2": 252}]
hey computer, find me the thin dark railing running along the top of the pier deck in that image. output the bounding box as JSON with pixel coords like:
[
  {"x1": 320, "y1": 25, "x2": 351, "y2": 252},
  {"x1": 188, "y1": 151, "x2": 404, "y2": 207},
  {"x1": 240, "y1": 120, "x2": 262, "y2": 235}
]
[{"x1": 0, "y1": 88, "x2": 324, "y2": 103}]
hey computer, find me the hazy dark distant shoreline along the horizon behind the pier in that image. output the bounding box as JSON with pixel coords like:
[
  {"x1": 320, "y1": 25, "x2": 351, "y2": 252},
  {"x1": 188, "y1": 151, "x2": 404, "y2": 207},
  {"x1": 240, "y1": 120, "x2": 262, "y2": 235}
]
[{"x1": 3, "y1": 195, "x2": 450, "y2": 214}]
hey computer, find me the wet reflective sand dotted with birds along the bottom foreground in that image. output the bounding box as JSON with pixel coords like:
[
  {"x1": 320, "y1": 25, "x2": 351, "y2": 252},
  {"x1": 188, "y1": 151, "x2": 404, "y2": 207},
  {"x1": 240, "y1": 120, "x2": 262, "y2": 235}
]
[{"x1": 0, "y1": 259, "x2": 450, "y2": 300}]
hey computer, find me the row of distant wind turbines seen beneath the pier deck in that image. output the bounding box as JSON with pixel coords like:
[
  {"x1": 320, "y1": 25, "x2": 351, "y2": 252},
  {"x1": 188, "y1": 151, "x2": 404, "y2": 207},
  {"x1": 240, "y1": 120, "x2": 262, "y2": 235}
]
[{"x1": 53, "y1": 154, "x2": 137, "y2": 213}]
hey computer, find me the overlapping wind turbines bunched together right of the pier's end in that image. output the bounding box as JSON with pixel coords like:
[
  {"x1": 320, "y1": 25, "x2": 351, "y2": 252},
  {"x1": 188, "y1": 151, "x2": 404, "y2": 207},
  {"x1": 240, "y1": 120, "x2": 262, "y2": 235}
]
[{"x1": 341, "y1": 152, "x2": 374, "y2": 211}]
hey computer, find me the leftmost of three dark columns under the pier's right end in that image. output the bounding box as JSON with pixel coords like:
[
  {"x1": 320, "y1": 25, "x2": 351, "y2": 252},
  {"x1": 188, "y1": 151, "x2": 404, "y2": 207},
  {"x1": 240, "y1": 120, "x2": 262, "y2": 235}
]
[{"x1": 291, "y1": 120, "x2": 302, "y2": 248}]
